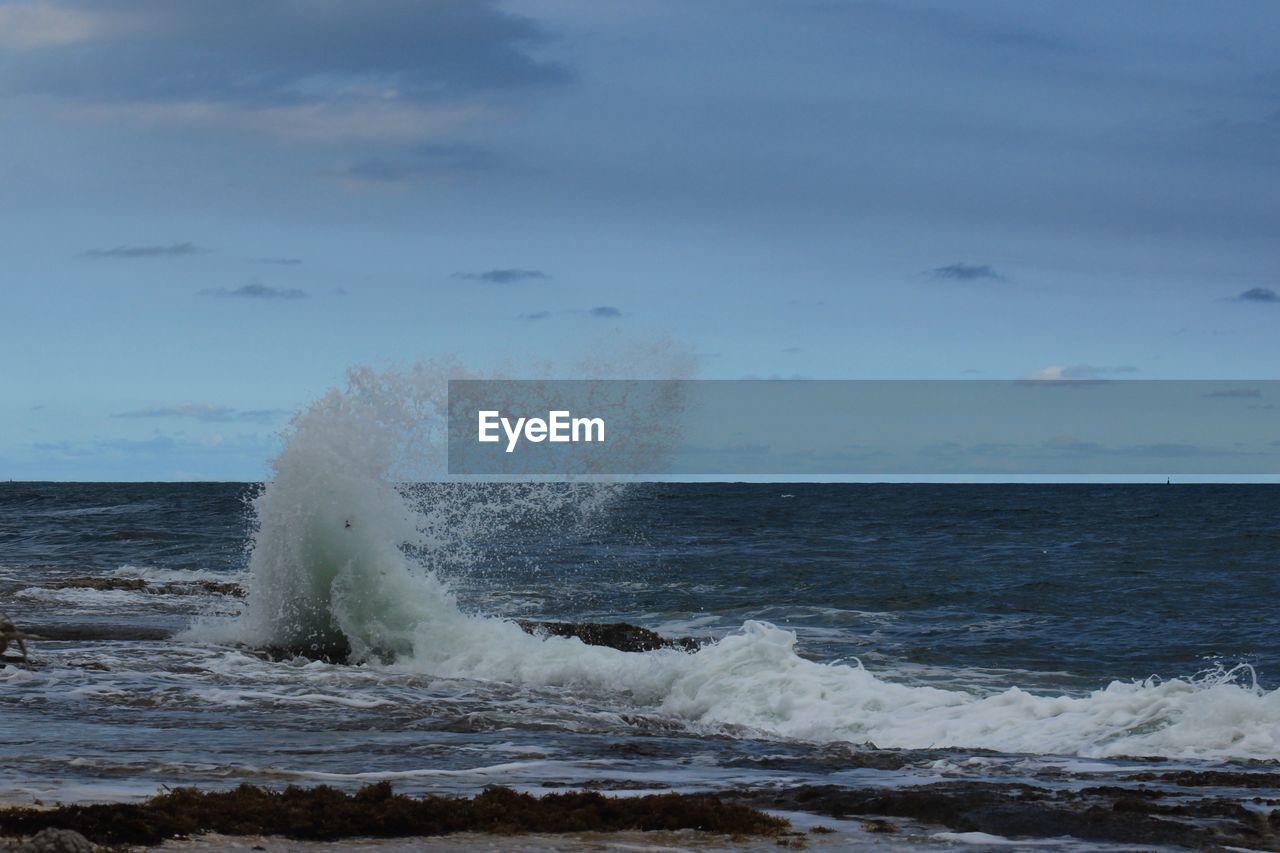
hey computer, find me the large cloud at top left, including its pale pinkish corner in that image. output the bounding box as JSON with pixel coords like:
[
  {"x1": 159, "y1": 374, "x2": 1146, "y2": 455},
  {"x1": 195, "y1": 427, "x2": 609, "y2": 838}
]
[{"x1": 0, "y1": 0, "x2": 571, "y2": 136}]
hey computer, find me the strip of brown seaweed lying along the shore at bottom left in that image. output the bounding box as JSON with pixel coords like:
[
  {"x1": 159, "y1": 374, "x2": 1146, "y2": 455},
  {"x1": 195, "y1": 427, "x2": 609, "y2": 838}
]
[{"x1": 0, "y1": 783, "x2": 788, "y2": 844}]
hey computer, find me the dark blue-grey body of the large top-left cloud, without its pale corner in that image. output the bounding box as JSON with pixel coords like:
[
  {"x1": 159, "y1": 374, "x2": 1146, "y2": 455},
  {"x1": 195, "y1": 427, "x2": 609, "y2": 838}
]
[{"x1": 0, "y1": 0, "x2": 568, "y2": 108}]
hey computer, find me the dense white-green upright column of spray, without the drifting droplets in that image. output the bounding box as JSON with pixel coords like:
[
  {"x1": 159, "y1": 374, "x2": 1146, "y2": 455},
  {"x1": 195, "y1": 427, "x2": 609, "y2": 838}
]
[{"x1": 239, "y1": 370, "x2": 447, "y2": 658}]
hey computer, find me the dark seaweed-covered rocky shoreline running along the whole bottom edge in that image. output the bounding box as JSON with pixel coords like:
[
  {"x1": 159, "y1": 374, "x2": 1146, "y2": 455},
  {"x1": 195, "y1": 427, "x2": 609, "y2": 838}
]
[{"x1": 0, "y1": 768, "x2": 1280, "y2": 850}]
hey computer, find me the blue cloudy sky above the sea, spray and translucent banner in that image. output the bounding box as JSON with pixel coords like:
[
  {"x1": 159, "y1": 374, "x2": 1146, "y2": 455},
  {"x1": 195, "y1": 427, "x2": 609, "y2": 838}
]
[{"x1": 0, "y1": 0, "x2": 1280, "y2": 480}]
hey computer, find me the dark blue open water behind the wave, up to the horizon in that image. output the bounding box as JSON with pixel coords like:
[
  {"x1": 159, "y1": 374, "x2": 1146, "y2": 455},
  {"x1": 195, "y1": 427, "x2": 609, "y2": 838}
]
[{"x1": 10, "y1": 484, "x2": 1280, "y2": 686}]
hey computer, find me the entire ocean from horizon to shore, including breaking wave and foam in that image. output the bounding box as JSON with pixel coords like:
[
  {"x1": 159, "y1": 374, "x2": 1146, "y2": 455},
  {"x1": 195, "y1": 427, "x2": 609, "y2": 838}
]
[{"x1": 0, "y1": 471, "x2": 1280, "y2": 840}]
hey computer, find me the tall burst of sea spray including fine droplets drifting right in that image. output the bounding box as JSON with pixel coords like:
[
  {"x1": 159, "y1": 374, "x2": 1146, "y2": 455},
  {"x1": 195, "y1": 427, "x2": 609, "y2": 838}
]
[{"x1": 226, "y1": 356, "x2": 689, "y2": 661}]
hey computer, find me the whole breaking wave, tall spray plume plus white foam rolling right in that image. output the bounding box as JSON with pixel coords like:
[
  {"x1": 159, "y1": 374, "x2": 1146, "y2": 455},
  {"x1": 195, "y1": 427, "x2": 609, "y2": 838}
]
[{"x1": 193, "y1": 365, "x2": 1280, "y2": 760}]
